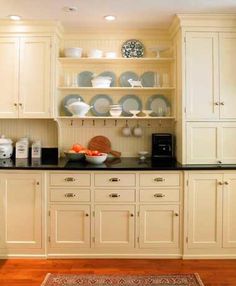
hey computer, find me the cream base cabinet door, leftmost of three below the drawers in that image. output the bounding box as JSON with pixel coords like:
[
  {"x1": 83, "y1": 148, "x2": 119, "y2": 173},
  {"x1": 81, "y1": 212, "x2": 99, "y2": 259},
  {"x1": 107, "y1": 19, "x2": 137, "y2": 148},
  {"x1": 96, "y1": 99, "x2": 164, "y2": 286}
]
[{"x1": 50, "y1": 205, "x2": 90, "y2": 248}]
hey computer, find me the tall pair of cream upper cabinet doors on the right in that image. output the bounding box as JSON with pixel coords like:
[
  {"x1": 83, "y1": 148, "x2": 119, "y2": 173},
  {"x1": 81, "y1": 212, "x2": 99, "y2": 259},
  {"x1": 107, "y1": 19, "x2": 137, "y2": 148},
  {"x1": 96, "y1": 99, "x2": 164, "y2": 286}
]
[{"x1": 185, "y1": 31, "x2": 236, "y2": 121}]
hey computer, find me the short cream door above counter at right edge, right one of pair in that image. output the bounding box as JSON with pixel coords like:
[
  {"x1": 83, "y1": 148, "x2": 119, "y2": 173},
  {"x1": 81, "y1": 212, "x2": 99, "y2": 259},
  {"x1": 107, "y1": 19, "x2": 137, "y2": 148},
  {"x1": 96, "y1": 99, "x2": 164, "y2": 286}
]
[{"x1": 218, "y1": 122, "x2": 236, "y2": 164}]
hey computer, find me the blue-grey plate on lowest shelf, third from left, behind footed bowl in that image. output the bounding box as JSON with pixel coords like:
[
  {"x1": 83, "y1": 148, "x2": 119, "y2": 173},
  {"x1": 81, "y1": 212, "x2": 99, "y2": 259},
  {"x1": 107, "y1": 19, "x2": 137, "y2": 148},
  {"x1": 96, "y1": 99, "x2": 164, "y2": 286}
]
[{"x1": 119, "y1": 95, "x2": 142, "y2": 116}]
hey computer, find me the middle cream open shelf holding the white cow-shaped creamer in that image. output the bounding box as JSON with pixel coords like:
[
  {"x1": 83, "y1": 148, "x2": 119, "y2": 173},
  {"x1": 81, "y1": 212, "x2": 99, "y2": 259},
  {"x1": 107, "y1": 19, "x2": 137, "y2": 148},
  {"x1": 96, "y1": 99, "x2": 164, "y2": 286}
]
[{"x1": 58, "y1": 86, "x2": 175, "y2": 91}]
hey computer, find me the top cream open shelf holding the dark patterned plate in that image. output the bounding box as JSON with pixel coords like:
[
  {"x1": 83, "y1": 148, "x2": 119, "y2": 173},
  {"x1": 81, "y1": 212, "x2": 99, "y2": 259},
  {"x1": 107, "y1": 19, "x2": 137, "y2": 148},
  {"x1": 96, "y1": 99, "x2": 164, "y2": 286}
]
[{"x1": 58, "y1": 57, "x2": 175, "y2": 64}]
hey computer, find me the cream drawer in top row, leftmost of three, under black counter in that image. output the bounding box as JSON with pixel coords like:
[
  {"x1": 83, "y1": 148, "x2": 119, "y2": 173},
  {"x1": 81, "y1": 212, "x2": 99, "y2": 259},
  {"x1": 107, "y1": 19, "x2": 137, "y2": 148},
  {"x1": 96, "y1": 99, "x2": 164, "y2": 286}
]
[{"x1": 50, "y1": 173, "x2": 90, "y2": 187}]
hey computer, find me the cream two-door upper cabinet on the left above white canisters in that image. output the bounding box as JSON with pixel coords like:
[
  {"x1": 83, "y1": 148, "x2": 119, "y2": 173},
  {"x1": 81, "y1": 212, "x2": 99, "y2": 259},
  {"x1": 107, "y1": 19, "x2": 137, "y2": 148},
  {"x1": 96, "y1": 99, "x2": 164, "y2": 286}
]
[{"x1": 0, "y1": 35, "x2": 53, "y2": 118}]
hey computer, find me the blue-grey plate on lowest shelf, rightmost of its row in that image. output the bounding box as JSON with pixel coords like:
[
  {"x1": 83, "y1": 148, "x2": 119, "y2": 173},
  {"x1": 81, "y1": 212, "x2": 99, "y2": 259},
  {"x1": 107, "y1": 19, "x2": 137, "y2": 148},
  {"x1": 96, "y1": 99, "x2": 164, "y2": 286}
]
[{"x1": 146, "y1": 94, "x2": 170, "y2": 116}]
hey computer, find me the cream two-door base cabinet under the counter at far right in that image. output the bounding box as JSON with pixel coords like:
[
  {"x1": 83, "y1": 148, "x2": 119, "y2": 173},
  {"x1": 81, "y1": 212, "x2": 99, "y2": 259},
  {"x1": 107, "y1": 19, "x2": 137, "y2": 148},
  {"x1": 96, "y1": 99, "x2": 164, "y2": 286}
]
[{"x1": 184, "y1": 171, "x2": 236, "y2": 257}]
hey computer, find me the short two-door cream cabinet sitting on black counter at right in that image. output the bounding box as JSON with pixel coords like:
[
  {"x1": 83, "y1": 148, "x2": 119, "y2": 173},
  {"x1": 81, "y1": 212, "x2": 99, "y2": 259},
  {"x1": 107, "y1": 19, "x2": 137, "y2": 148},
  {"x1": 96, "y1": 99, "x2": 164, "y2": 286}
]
[{"x1": 186, "y1": 122, "x2": 236, "y2": 164}]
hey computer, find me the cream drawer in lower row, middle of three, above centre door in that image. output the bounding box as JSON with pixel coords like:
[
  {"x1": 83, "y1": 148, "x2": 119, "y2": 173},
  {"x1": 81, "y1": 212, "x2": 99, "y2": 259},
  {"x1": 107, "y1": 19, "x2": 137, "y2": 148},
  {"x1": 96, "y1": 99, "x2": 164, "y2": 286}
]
[{"x1": 95, "y1": 190, "x2": 135, "y2": 203}]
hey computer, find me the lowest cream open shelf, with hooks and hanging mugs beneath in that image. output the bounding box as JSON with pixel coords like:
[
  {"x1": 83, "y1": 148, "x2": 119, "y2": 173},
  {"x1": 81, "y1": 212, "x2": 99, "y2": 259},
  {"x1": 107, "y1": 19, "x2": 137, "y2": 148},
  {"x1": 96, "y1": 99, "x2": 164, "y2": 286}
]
[{"x1": 56, "y1": 116, "x2": 175, "y2": 120}]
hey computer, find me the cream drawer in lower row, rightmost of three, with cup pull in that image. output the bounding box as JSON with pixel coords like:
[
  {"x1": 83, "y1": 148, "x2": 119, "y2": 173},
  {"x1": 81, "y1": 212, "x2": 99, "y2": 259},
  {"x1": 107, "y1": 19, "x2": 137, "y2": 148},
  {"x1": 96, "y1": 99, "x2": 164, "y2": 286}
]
[{"x1": 140, "y1": 189, "x2": 179, "y2": 203}]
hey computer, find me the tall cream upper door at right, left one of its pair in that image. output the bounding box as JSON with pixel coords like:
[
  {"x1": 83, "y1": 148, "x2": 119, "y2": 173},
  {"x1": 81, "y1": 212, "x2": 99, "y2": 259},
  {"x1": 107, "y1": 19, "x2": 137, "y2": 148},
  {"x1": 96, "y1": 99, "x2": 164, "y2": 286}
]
[{"x1": 186, "y1": 32, "x2": 219, "y2": 120}]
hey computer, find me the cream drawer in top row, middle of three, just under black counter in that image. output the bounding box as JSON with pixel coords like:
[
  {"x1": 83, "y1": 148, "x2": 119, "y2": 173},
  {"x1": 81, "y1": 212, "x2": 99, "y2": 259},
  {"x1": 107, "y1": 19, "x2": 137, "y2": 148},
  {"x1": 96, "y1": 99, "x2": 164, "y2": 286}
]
[{"x1": 95, "y1": 173, "x2": 135, "y2": 187}]
